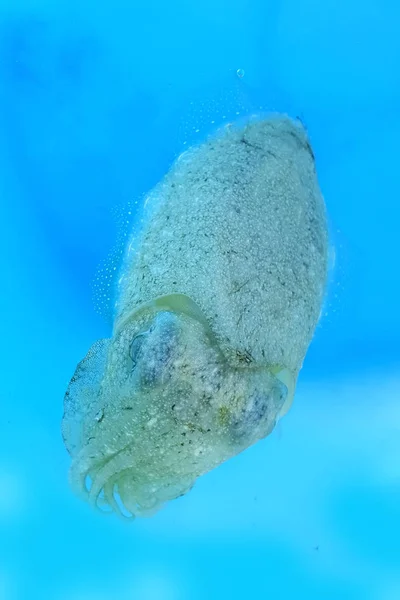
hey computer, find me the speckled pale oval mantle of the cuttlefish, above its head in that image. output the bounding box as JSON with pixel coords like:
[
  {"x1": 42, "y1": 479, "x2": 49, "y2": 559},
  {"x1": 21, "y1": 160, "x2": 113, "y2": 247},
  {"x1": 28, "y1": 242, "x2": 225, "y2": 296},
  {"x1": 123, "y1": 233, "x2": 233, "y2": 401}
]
[{"x1": 117, "y1": 119, "x2": 327, "y2": 372}]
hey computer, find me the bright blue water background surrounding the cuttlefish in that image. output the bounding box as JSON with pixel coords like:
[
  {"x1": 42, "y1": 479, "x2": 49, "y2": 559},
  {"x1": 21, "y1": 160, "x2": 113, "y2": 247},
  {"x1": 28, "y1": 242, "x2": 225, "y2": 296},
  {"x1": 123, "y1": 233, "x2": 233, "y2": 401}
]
[{"x1": 0, "y1": 0, "x2": 400, "y2": 600}]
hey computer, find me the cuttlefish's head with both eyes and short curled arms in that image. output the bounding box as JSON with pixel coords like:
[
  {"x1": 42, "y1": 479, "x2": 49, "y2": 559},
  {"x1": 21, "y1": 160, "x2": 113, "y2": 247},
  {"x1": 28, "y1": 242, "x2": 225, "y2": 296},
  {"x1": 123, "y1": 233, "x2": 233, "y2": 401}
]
[{"x1": 62, "y1": 294, "x2": 294, "y2": 517}]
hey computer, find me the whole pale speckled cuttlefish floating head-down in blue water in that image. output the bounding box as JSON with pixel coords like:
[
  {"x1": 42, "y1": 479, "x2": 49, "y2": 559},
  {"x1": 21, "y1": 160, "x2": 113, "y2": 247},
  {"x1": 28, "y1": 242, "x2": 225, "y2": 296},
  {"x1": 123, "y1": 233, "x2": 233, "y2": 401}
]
[{"x1": 62, "y1": 115, "x2": 328, "y2": 517}]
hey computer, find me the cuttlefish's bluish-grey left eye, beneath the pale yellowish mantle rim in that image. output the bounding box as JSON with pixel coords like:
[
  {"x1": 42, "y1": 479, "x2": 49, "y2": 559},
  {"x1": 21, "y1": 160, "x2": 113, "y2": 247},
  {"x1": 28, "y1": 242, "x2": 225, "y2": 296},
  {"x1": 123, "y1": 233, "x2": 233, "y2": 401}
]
[{"x1": 129, "y1": 311, "x2": 179, "y2": 386}]
